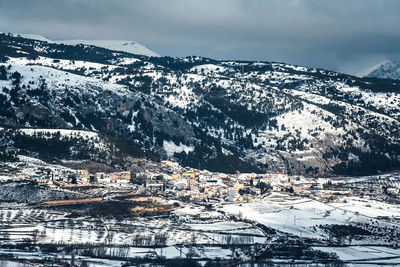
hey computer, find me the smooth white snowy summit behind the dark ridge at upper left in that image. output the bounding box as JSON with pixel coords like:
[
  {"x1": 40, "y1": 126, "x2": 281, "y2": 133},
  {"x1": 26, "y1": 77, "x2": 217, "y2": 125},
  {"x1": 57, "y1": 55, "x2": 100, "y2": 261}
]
[{"x1": 17, "y1": 34, "x2": 160, "y2": 57}]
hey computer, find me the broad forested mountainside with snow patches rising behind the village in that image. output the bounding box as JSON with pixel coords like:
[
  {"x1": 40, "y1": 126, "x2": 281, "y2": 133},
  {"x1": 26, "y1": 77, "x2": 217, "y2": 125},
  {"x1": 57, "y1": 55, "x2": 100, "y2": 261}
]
[{"x1": 0, "y1": 34, "x2": 400, "y2": 175}]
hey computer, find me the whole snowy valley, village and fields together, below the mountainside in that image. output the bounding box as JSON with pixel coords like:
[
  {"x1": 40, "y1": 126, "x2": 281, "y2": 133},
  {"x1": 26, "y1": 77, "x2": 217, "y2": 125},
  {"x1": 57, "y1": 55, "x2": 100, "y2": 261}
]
[{"x1": 0, "y1": 161, "x2": 400, "y2": 266}]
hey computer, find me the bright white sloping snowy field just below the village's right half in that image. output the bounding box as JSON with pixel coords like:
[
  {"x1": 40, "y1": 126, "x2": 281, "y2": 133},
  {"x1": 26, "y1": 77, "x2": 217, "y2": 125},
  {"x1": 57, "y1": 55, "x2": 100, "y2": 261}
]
[{"x1": 222, "y1": 193, "x2": 400, "y2": 239}]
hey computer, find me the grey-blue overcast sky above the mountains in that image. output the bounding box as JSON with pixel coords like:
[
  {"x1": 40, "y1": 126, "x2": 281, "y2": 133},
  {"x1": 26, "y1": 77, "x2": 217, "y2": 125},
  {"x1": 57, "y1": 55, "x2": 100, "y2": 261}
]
[{"x1": 0, "y1": 0, "x2": 400, "y2": 74}]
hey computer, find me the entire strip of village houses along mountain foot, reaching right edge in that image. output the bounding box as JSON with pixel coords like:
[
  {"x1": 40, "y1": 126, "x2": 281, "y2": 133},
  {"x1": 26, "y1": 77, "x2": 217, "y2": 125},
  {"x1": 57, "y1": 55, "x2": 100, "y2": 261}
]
[{"x1": 18, "y1": 161, "x2": 400, "y2": 210}]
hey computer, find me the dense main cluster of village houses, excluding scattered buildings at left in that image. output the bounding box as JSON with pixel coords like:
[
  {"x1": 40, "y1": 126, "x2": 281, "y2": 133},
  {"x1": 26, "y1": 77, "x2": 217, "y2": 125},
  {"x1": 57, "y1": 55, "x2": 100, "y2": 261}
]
[{"x1": 140, "y1": 168, "x2": 352, "y2": 202}]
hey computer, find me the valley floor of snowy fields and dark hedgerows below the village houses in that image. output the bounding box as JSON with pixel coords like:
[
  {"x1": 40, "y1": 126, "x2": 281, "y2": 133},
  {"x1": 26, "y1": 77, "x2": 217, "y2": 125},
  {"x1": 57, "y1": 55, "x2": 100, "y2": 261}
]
[{"x1": 0, "y1": 178, "x2": 400, "y2": 266}]
